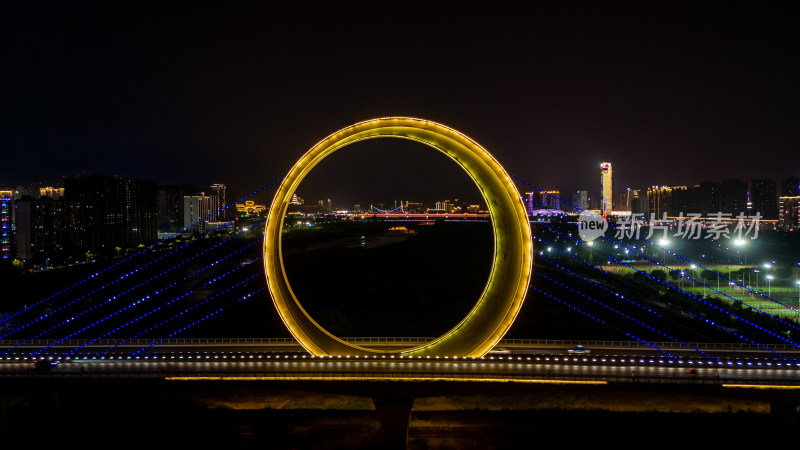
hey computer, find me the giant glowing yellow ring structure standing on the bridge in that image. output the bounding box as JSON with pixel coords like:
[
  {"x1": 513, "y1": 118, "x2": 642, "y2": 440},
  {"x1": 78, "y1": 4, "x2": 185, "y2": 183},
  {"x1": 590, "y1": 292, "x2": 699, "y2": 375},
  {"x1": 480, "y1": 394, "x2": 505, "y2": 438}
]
[{"x1": 264, "y1": 117, "x2": 533, "y2": 357}]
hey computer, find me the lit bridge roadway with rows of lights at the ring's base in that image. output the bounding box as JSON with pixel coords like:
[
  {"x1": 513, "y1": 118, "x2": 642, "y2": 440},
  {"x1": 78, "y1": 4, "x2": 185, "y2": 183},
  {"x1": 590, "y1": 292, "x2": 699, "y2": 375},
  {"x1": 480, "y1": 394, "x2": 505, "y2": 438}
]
[{"x1": 0, "y1": 340, "x2": 800, "y2": 386}]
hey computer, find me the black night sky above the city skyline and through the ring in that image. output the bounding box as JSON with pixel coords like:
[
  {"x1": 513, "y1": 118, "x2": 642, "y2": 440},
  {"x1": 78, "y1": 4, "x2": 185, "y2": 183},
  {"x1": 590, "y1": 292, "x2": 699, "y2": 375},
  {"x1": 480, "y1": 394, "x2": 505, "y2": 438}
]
[{"x1": 0, "y1": 1, "x2": 800, "y2": 206}]
